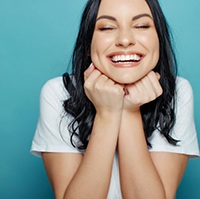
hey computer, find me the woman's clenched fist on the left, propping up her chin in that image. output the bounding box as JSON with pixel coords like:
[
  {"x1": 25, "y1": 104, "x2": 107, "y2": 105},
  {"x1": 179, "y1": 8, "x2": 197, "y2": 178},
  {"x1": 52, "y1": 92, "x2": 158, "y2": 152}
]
[{"x1": 84, "y1": 64, "x2": 124, "y2": 112}]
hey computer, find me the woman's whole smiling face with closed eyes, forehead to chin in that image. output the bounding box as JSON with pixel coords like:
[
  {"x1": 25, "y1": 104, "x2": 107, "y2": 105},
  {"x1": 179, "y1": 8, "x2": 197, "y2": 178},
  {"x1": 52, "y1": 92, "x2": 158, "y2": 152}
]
[{"x1": 91, "y1": 0, "x2": 159, "y2": 84}]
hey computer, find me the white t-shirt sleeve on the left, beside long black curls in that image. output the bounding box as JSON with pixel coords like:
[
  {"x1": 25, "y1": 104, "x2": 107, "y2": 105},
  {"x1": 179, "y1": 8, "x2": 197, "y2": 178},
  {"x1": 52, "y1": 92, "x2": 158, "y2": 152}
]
[{"x1": 31, "y1": 77, "x2": 79, "y2": 156}]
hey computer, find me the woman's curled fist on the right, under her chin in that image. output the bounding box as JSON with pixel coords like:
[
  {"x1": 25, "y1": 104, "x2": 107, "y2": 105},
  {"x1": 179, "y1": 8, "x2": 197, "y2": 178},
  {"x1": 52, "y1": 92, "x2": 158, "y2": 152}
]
[{"x1": 124, "y1": 71, "x2": 162, "y2": 111}]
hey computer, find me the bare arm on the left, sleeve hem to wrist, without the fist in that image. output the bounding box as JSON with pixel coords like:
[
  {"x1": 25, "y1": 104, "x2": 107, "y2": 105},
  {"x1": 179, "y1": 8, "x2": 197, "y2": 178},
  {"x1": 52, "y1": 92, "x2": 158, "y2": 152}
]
[{"x1": 43, "y1": 112, "x2": 119, "y2": 199}]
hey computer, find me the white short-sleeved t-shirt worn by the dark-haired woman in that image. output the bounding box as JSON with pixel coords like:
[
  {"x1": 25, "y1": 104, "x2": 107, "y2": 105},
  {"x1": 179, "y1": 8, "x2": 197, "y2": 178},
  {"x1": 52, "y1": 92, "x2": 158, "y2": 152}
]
[{"x1": 31, "y1": 77, "x2": 199, "y2": 199}]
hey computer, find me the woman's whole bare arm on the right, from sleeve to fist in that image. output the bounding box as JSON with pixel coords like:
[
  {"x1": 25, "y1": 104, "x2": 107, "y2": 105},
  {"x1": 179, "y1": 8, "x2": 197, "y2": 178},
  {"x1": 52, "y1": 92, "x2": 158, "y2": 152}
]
[{"x1": 118, "y1": 73, "x2": 188, "y2": 199}]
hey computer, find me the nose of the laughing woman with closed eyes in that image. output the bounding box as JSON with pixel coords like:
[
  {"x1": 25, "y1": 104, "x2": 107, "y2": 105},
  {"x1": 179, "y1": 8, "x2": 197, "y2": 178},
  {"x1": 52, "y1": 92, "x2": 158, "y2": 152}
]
[{"x1": 116, "y1": 30, "x2": 135, "y2": 48}]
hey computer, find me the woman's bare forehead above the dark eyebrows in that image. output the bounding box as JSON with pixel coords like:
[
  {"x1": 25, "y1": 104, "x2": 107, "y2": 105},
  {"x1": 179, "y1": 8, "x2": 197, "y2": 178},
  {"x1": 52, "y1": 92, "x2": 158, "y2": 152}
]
[{"x1": 98, "y1": 0, "x2": 152, "y2": 16}]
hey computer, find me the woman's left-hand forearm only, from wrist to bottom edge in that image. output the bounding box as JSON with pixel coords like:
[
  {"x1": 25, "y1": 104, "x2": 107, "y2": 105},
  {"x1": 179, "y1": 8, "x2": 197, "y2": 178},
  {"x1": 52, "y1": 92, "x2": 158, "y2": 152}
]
[{"x1": 64, "y1": 112, "x2": 121, "y2": 199}]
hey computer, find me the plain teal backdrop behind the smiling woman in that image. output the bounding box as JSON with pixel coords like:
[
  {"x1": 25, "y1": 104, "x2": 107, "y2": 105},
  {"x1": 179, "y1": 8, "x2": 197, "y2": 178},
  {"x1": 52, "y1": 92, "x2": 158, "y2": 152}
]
[{"x1": 0, "y1": 0, "x2": 200, "y2": 199}]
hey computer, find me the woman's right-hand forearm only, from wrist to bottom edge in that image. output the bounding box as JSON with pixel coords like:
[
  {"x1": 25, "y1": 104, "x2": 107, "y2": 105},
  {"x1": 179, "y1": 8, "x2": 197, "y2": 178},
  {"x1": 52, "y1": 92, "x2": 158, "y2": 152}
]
[{"x1": 118, "y1": 111, "x2": 165, "y2": 199}]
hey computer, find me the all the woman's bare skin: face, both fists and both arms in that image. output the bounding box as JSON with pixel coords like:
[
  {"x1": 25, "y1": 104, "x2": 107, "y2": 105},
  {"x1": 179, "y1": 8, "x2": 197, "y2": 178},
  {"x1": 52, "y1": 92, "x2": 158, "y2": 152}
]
[{"x1": 42, "y1": 0, "x2": 188, "y2": 199}]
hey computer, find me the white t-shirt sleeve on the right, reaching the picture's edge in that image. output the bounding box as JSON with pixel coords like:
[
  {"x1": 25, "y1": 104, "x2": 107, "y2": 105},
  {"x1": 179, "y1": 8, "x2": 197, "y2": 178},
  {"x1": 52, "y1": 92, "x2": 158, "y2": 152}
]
[{"x1": 149, "y1": 77, "x2": 199, "y2": 157}]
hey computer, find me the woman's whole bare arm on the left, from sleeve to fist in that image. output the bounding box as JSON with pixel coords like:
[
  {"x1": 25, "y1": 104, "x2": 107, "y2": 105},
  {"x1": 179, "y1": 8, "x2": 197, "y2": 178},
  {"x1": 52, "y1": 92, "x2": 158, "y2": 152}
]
[{"x1": 43, "y1": 65, "x2": 124, "y2": 199}]
